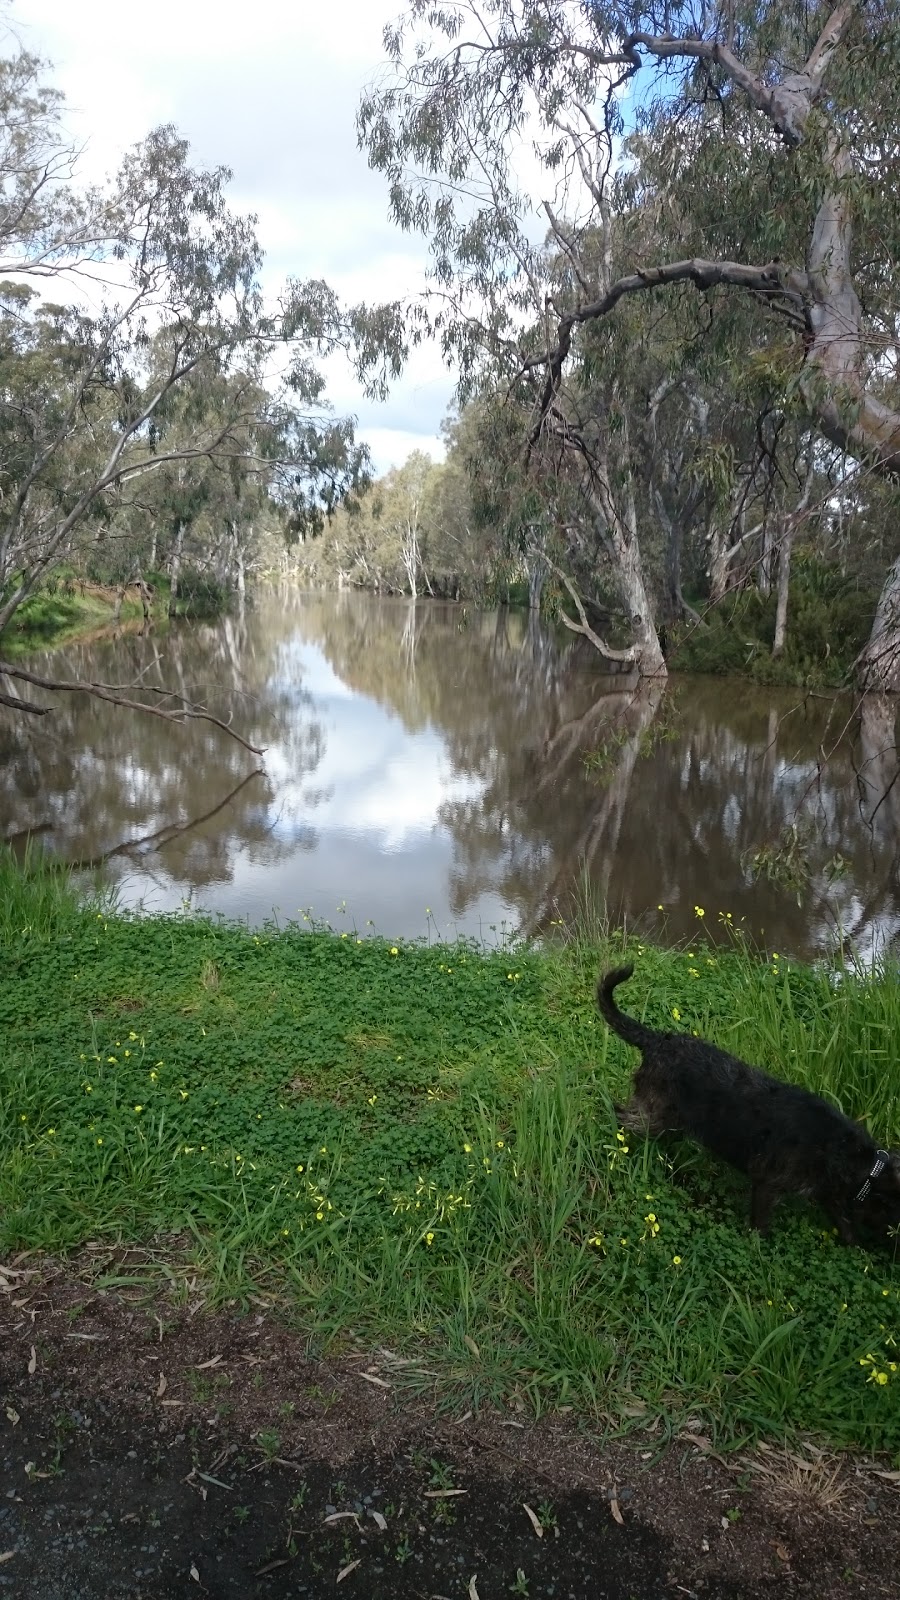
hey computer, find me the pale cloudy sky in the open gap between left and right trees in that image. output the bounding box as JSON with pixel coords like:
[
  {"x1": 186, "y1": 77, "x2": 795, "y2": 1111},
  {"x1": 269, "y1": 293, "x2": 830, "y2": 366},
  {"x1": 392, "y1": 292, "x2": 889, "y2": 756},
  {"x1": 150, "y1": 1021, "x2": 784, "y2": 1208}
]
[{"x1": 8, "y1": 0, "x2": 453, "y2": 474}]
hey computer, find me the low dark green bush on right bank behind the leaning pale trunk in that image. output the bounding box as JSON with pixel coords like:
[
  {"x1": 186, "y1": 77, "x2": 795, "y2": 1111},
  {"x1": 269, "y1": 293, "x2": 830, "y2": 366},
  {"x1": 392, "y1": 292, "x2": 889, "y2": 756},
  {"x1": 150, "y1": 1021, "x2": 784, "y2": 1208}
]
[{"x1": 669, "y1": 554, "x2": 878, "y2": 688}]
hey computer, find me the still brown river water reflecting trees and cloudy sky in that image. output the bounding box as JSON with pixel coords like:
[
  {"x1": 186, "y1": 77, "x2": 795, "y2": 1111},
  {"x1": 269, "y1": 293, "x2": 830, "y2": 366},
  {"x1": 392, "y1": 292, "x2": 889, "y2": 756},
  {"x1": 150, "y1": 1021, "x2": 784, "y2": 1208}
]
[{"x1": 0, "y1": 590, "x2": 900, "y2": 955}]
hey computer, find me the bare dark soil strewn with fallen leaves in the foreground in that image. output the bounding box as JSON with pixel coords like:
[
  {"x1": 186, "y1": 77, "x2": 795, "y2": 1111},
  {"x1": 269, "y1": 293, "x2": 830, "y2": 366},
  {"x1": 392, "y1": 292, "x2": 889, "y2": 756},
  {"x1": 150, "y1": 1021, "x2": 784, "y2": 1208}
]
[{"x1": 0, "y1": 1246, "x2": 900, "y2": 1600}]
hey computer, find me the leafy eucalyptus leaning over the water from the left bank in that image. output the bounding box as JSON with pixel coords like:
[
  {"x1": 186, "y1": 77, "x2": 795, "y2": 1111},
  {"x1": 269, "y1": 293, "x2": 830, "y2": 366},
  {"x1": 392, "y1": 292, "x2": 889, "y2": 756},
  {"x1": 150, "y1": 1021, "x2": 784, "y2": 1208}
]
[{"x1": 0, "y1": 43, "x2": 377, "y2": 732}]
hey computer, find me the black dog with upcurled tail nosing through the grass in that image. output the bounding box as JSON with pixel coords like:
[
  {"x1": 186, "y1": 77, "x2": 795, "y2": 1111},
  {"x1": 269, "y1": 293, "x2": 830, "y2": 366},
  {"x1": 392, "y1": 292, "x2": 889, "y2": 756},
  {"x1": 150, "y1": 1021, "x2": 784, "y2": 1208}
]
[{"x1": 597, "y1": 966, "x2": 900, "y2": 1245}]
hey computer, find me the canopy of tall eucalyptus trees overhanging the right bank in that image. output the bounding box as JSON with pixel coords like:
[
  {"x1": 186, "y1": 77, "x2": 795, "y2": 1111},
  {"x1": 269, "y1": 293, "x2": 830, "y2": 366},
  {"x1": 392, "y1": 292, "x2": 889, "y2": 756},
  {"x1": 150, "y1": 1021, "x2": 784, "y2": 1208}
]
[{"x1": 359, "y1": 0, "x2": 900, "y2": 688}]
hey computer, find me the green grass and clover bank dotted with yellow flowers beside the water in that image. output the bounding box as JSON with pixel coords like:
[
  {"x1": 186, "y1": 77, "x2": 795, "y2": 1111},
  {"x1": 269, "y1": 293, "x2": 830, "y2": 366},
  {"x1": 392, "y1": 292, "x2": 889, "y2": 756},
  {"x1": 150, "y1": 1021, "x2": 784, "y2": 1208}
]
[{"x1": 0, "y1": 861, "x2": 900, "y2": 1458}]
